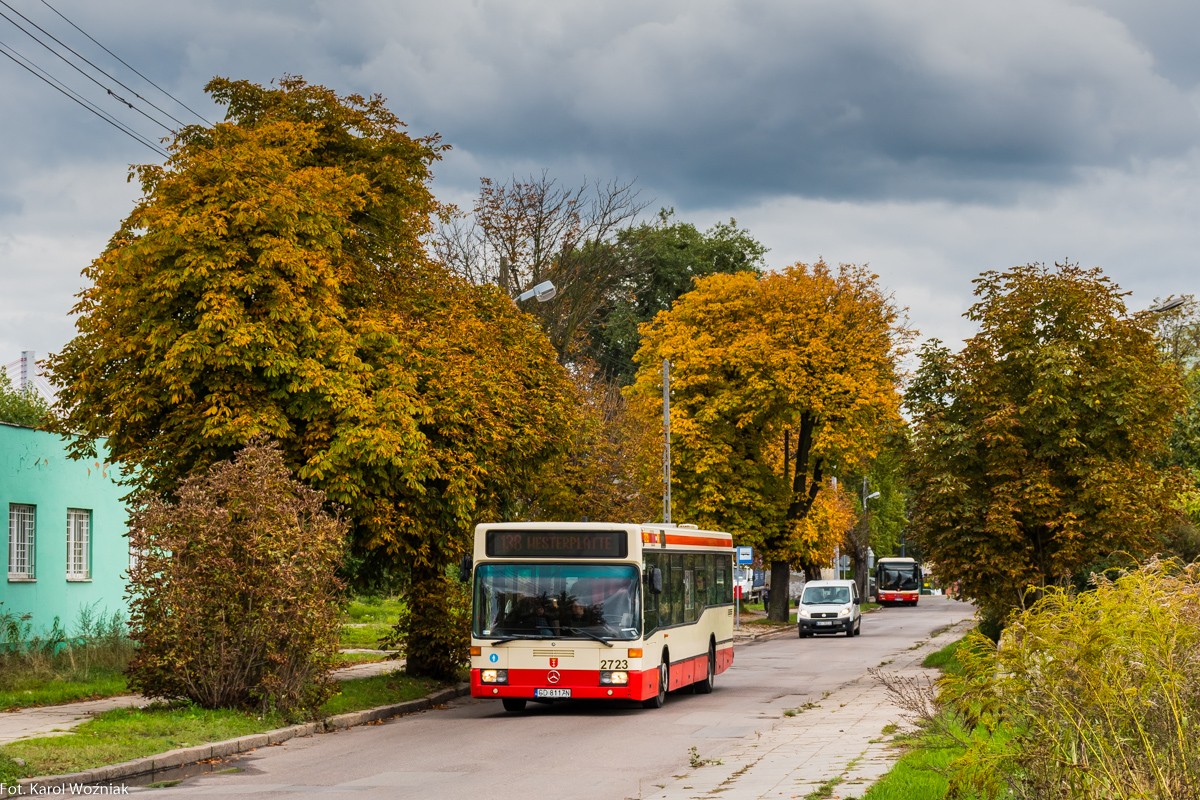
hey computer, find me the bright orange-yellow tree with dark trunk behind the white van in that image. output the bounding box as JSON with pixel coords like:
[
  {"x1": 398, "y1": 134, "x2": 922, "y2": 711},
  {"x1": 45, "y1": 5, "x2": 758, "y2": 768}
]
[{"x1": 632, "y1": 263, "x2": 908, "y2": 620}]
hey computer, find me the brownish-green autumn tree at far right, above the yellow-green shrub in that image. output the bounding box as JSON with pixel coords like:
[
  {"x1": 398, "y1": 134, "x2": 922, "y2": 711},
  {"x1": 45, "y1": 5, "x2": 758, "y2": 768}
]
[{"x1": 906, "y1": 263, "x2": 1181, "y2": 621}]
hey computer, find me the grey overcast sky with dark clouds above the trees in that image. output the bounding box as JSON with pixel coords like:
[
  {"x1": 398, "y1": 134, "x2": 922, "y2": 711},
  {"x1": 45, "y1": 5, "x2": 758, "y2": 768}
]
[{"x1": 0, "y1": 0, "x2": 1200, "y2": 383}]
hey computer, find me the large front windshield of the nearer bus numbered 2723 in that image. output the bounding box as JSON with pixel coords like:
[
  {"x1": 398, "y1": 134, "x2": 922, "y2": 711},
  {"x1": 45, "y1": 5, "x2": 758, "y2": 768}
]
[{"x1": 472, "y1": 564, "x2": 642, "y2": 639}]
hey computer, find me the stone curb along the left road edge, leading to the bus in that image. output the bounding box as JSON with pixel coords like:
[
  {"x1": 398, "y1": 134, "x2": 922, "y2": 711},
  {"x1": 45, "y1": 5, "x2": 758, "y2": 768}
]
[{"x1": 17, "y1": 682, "x2": 470, "y2": 789}]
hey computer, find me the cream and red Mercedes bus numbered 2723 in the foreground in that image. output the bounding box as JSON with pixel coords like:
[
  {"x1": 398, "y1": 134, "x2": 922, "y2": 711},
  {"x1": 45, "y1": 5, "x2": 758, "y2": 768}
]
[{"x1": 470, "y1": 522, "x2": 733, "y2": 711}]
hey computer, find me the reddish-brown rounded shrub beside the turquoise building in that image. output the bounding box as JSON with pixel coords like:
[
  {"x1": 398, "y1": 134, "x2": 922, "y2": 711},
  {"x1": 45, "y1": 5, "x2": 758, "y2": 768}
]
[{"x1": 128, "y1": 441, "x2": 346, "y2": 717}]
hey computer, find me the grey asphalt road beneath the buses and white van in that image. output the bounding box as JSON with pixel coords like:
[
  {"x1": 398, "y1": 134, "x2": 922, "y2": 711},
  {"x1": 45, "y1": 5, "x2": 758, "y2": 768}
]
[{"x1": 146, "y1": 597, "x2": 973, "y2": 800}]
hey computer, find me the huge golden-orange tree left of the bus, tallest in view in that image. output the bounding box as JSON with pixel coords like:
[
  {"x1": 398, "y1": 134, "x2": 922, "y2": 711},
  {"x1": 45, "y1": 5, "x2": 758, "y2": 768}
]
[{"x1": 49, "y1": 77, "x2": 566, "y2": 676}]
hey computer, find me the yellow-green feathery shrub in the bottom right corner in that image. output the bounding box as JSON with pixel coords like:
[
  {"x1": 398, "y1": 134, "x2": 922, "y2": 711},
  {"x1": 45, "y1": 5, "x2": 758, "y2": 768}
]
[{"x1": 937, "y1": 561, "x2": 1200, "y2": 800}]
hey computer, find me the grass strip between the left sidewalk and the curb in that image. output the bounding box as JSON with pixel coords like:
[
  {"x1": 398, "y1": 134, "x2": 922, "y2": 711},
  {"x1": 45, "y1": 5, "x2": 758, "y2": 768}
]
[{"x1": 0, "y1": 673, "x2": 440, "y2": 783}]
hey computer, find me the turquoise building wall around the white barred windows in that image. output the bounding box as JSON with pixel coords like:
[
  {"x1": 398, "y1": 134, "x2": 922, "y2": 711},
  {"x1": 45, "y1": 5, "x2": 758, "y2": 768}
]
[{"x1": 0, "y1": 422, "x2": 130, "y2": 631}]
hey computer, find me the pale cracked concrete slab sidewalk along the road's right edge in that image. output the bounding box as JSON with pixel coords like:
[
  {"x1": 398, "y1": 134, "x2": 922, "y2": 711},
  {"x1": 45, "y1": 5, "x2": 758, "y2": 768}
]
[{"x1": 643, "y1": 620, "x2": 974, "y2": 800}]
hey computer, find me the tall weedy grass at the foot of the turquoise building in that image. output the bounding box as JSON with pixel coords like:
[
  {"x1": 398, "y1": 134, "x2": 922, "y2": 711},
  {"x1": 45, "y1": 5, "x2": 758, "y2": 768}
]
[{"x1": 0, "y1": 603, "x2": 134, "y2": 710}]
